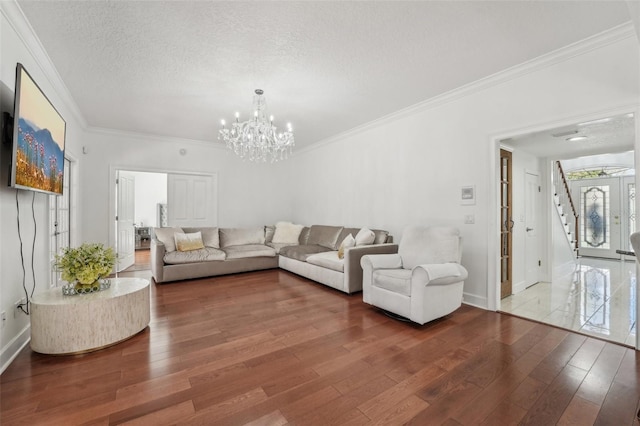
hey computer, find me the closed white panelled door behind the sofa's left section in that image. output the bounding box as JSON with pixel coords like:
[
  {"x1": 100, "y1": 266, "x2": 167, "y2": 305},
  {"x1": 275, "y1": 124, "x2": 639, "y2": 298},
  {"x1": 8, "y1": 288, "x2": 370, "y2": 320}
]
[{"x1": 167, "y1": 174, "x2": 218, "y2": 227}]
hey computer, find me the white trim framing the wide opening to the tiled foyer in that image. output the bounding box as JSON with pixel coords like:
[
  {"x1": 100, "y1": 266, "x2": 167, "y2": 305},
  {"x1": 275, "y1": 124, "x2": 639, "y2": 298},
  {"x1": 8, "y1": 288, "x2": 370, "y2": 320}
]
[{"x1": 486, "y1": 103, "x2": 640, "y2": 350}]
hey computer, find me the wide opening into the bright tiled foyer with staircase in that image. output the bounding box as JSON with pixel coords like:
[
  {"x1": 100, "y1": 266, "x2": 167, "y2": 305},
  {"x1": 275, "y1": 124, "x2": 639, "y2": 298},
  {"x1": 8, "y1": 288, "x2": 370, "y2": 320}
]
[{"x1": 496, "y1": 113, "x2": 637, "y2": 346}]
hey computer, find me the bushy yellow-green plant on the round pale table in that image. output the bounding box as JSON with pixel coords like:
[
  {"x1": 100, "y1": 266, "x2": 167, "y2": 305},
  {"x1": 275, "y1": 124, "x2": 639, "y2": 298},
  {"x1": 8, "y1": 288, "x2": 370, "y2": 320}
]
[{"x1": 54, "y1": 243, "x2": 117, "y2": 284}]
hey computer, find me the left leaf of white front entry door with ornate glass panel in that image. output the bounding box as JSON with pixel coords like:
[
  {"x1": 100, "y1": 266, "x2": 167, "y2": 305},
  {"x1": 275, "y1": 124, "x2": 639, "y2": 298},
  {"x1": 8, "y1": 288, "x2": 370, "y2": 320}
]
[{"x1": 572, "y1": 177, "x2": 622, "y2": 259}]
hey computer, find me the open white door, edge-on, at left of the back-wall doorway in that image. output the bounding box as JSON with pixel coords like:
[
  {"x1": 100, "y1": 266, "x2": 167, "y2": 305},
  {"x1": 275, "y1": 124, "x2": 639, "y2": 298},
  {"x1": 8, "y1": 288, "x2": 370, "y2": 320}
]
[{"x1": 116, "y1": 171, "x2": 136, "y2": 272}]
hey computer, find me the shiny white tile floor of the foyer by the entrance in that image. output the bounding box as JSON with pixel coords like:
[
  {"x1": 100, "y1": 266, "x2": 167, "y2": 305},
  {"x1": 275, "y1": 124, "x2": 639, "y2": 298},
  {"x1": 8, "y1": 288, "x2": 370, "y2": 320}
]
[{"x1": 500, "y1": 257, "x2": 637, "y2": 347}]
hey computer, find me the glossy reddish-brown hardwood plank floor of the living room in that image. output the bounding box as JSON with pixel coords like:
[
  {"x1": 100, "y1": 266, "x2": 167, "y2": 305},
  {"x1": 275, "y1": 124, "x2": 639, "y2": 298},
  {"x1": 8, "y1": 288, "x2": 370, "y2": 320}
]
[{"x1": 0, "y1": 270, "x2": 640, "y2": 425}]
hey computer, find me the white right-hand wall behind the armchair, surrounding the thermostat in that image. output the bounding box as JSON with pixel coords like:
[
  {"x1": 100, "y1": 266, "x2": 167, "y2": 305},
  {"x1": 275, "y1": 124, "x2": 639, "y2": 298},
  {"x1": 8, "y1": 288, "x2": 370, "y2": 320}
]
[{"x1": 289, "y1": 32, "x2": 640, "y2": 307}]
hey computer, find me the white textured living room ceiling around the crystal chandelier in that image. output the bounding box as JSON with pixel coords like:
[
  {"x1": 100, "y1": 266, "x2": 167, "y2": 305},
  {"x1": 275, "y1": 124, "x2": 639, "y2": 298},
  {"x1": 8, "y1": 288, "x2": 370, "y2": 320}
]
[{"x1": 18, "y1": 0, "x2": 630, "y2": 150}]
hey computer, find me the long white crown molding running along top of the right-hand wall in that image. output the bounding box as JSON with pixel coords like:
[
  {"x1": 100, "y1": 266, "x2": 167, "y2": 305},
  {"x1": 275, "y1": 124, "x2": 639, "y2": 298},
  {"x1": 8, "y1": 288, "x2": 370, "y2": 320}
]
[{"x1": 298, "y1": 22, "x2": 636, "y2": 154}]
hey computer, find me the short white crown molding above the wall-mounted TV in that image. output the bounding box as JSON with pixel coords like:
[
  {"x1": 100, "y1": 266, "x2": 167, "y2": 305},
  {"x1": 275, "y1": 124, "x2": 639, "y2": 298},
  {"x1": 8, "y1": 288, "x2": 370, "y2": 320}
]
[{"x1": 0, "y1": 0, "x2": 87, "y2": 129}]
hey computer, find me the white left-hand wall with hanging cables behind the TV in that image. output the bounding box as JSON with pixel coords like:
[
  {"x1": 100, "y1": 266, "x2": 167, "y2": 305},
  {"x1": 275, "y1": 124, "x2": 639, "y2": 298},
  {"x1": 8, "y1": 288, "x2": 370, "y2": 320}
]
[{"x1": 0, "y1": 2, "x2": 84, "y2": 371}]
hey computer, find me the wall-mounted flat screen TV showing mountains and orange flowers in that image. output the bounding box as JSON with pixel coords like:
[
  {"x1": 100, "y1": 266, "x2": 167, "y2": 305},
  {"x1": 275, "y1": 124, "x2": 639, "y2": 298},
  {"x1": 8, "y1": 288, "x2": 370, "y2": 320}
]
[{"x1": 9, "y1": 64, "x2": 67, "y2": 195}]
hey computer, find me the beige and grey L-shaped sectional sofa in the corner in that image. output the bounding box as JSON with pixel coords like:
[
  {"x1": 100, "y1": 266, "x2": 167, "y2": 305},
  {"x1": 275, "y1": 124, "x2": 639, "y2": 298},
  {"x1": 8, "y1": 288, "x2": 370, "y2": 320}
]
[{"x1": 151, "y1": 225, "x2": 398, "y2": 293}]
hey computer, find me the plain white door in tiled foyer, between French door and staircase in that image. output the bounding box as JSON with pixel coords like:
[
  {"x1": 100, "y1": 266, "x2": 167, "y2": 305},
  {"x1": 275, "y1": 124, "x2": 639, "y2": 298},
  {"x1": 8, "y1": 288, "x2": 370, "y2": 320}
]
[{"x1": 524, "y1": 172, "x2": 540, "y2": 287}]
